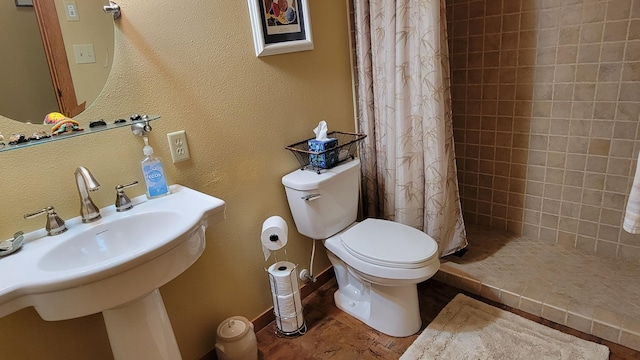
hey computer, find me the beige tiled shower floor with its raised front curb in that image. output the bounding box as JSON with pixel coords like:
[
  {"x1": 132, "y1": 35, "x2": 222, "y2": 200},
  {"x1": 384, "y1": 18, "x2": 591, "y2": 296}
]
[{"x1": 435, "y1": 227, "x2": 640, "y2": 350}]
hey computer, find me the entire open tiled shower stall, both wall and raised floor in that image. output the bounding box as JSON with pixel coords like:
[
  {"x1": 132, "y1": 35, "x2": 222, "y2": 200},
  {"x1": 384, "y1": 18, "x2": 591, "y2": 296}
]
[{"x1": 436, "y1": 0, "x2": 640, "y2": 350}]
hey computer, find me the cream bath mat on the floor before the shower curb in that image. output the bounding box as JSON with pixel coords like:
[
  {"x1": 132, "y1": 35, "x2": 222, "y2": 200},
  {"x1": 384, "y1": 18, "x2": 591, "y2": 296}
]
[{"x1": 400, "y1": 294, "x2": 609, "y2": 360}]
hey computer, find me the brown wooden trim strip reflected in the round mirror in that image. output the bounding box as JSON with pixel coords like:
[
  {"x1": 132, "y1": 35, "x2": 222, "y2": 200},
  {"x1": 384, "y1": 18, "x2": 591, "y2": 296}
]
[{"x1": 33, "y1": 0, "x2": 86, "y2": 118}]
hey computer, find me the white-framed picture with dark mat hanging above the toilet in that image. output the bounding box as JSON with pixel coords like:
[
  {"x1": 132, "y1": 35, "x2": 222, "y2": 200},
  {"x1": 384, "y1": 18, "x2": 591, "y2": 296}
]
[{"x1": 247, "y1": 0, "x2": 313, "y2": 57}]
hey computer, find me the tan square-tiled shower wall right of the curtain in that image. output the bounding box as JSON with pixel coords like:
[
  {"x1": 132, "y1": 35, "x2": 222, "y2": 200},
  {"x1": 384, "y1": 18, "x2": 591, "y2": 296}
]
[{"x1": 446, "y1": 0, "x2": 640, "y2": 261}]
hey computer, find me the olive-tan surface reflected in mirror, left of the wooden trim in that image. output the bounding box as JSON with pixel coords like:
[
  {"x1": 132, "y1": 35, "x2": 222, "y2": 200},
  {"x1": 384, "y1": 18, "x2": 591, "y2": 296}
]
[{"x1": 0, "y1": 1, "x2": 58, "y2": 122}]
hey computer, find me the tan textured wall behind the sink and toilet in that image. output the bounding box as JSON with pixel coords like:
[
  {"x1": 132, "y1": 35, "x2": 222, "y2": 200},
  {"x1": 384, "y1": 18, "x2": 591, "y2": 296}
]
[{"x1": 0, "y1": 0, "x2": 354, "y2": 360}]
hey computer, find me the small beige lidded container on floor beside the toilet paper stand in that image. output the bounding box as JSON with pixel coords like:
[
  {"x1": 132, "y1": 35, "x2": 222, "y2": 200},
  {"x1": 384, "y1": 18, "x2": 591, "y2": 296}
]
[{"x1": 216, "y1": 316, "x2": 258, "y2": 360}]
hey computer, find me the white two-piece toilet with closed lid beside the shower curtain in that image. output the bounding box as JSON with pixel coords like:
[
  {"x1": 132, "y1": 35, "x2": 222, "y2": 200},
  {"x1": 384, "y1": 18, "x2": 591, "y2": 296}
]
[{"x1": 282, "y1": 159, "x2": 440, "y2": 337}]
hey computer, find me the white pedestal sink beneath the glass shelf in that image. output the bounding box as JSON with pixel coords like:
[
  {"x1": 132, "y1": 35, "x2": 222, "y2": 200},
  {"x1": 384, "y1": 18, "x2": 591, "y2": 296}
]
[{"x1": 0, "y1": 185, "x2": 225, "y2": 360}]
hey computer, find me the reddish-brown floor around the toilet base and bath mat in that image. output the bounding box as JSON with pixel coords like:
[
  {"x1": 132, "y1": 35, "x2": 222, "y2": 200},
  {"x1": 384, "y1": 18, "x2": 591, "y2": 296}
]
[{"x1": 257, "y1": 279, "x2": 640, "y2": 360}]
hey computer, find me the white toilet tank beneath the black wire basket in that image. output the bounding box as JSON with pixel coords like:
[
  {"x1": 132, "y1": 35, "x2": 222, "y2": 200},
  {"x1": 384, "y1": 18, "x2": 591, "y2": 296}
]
[{"x1": 282, "y1": 159, "x2": 360, "y2": 239}]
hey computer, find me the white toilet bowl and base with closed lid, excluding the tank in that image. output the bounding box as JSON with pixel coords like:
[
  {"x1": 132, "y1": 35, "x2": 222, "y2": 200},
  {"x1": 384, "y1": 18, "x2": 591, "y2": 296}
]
[{"x1": 324, "y1": 219, "x2": 440, "y2": 337}]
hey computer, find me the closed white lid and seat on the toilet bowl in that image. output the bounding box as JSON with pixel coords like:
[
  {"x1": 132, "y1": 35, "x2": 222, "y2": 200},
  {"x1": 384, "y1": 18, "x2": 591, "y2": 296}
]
[{"x1": 341, "y1": 219, "x2": 438, "y2": 269}]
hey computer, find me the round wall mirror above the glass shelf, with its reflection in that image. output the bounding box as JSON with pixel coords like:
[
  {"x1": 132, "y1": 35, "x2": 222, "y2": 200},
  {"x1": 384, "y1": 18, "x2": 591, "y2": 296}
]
[{"x1": 0, "y1": 0, "x2": 114, "y2": 124}]
